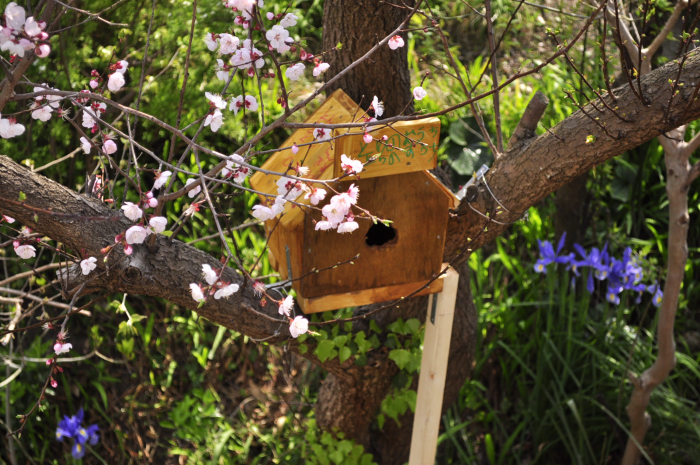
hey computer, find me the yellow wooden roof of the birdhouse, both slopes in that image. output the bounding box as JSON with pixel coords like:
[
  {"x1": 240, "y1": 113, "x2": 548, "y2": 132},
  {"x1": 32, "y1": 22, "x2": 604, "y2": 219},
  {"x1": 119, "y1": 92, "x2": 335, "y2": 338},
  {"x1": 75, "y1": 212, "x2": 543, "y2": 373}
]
[{"x1": 250, "y1": 89, "x2": 459, "y2": 227}]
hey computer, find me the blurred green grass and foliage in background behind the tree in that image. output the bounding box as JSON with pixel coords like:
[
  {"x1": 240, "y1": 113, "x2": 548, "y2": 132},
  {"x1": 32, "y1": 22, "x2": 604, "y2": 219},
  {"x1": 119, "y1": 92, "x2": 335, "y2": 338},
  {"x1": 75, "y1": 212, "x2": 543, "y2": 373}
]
[{"x1": 0, "y1": 0, "x2": 700, "y2": 465}]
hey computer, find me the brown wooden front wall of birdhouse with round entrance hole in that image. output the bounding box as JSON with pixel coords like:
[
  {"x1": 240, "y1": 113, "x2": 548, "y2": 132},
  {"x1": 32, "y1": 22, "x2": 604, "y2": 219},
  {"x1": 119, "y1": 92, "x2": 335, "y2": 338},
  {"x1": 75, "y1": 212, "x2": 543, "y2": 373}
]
[{"x1": 298, "y1": 171, "x2": 450, "y2": 299}]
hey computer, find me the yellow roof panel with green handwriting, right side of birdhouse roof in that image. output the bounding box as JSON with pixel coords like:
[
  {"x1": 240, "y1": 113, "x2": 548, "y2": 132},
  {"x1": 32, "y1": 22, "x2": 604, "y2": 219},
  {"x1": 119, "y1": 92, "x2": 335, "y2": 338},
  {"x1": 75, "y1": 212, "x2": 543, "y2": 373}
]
[{"x1": 334, "y1": 118, "x2": 440, "y2": 179}]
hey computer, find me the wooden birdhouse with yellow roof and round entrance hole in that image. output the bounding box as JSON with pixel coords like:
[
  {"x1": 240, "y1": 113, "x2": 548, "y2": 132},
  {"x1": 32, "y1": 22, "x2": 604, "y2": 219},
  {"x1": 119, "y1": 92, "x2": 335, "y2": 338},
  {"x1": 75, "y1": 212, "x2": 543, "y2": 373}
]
[{"x1": 250, "y1": 90, "x2": 459, "y2": 313}]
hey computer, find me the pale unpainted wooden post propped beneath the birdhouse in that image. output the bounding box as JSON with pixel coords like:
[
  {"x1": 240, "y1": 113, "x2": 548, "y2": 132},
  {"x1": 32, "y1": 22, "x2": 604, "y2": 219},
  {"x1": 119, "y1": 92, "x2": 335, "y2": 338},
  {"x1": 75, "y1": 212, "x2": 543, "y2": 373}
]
[{"x1": 408, "y1": 268, "x2": 459, "y2": 465}]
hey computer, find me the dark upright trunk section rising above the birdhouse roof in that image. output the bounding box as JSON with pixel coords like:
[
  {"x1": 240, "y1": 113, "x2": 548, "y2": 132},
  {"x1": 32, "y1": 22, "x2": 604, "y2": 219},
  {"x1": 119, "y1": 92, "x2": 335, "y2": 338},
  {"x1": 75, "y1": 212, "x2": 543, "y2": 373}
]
[{"x1": 323, "y1": 0, "x2": 415, "y2": 116}]
